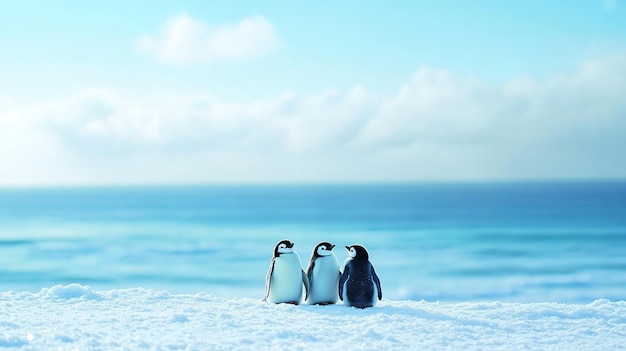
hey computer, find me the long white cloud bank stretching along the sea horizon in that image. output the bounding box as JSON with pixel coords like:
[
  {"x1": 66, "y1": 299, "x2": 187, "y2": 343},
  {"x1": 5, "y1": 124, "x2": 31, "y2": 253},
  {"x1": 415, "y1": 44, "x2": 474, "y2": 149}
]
[{"x1": 0, "y1": 55, "x2": 626, "y2": 184}]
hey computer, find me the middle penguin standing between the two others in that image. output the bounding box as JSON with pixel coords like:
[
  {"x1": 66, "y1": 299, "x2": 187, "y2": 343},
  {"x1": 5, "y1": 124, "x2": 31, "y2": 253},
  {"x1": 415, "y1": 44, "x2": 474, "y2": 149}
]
[{"x1": 306, "y1": 241, "x2": 341, "y2": 305}]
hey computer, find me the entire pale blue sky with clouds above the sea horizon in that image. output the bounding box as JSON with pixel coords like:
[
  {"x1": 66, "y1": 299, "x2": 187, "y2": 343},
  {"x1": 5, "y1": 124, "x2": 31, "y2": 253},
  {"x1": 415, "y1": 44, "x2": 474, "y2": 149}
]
[{"x1": 0, "y1": 0, "x2": 626, "y2": 187}]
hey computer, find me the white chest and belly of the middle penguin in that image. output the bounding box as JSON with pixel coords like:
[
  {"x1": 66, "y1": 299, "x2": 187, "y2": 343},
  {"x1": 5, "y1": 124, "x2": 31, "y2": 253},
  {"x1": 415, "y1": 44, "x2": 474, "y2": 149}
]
[{"x1": 308, "y1": 255, "x2": 339, "y2": 304}]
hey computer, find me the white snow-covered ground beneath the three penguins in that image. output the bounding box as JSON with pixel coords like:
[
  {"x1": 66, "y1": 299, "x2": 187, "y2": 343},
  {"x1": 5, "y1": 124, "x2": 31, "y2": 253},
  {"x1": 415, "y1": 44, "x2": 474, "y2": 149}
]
[{"x1": 0, "y1": 284, "x2": 626, "y2": 350}]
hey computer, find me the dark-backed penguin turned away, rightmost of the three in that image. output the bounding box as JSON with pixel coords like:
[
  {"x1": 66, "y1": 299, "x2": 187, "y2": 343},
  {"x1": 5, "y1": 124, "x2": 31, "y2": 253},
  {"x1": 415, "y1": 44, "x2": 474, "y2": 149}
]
[{"x1": 338, "y1": 245, "x2": 383, "y2": 308}]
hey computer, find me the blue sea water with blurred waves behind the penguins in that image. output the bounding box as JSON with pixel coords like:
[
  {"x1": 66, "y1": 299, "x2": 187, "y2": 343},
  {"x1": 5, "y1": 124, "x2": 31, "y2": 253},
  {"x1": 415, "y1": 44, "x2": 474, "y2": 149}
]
[{"x1": 0, "y1": 182, "x2": 626, "y2": 303}]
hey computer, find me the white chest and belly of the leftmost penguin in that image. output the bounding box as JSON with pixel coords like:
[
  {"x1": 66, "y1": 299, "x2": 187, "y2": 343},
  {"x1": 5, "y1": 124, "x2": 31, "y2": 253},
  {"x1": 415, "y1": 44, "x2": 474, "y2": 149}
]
[{"x1": 268, "y1": 253, "x2": 302, "y2": 303}]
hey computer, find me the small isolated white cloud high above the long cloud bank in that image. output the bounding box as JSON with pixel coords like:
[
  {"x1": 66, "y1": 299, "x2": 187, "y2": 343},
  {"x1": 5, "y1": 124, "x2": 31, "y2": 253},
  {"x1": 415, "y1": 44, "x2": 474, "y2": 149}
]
[{"x1": 137, "y1": 14, "x2": 280, "y2": 65}]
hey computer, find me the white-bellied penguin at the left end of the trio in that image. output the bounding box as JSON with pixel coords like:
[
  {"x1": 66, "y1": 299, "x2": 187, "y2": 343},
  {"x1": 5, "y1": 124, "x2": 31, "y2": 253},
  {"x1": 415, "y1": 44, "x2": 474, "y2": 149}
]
[{"x1": 264, "y1": 240, "x2": 309, "y2": 305}]
